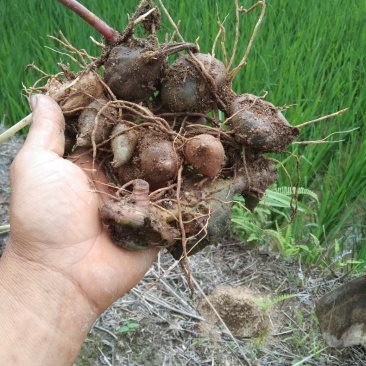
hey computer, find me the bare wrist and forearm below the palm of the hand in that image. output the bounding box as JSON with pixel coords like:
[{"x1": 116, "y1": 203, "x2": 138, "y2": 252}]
[{"x1": 0, "y1": 244, "x2": 99, "y2": 365}]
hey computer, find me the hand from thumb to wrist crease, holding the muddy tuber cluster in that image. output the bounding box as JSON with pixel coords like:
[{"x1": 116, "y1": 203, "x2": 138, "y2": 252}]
[{"x1": 10, "y1": 95, "x2": 156, "y2": 311}]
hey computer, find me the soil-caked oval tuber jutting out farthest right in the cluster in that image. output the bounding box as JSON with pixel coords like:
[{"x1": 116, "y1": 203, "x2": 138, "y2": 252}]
[{"x1": 227, "y1": 94, "x2": 300, "y2": 152}]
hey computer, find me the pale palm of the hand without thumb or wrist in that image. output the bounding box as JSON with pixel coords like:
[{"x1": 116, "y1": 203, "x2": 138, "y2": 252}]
[{"x1": 11, "y1": 151, "x2": 157, "y2": 308}]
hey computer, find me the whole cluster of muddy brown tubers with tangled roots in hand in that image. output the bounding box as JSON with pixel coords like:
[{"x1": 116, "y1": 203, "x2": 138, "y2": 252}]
[{"x1": 25, "y1": 0, "x2": 299, "y2": 259}]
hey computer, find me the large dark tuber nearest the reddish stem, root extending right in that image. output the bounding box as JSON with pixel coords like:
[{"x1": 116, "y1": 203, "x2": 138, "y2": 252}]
[{"x1": 104, "y1": 40, "x2": 197, "y2": 103}]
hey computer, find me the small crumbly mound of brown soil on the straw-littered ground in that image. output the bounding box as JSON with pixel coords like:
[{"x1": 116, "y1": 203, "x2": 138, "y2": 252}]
[{"x1": 198, "y1": 285, "x2": 269, "y2": 338}]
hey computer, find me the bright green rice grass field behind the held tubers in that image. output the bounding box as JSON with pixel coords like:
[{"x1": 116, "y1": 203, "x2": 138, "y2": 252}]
[{"x1": 0, "y1": 0, "x2": 366, "y2": 260}]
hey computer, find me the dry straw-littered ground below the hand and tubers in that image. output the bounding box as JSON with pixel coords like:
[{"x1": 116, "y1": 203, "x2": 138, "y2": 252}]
[{"x1": 0, "y1": 126, "x2": 366, "y2": 366}]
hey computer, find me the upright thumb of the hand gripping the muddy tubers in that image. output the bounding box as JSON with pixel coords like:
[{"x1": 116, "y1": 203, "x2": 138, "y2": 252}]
[{"x1": 24, "y1": 94, "x2": 65, "y2": 156}]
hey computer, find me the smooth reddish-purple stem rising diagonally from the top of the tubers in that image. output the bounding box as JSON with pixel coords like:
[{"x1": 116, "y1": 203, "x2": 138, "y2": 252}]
[{"x1": 57, "y1": 0, "x2": 119, "y2": 42}]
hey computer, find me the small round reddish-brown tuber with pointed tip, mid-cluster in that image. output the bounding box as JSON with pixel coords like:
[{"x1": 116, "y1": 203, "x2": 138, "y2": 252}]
[{"x1": 184, "y1": 134, "x2": 225, "y2": 178}]
